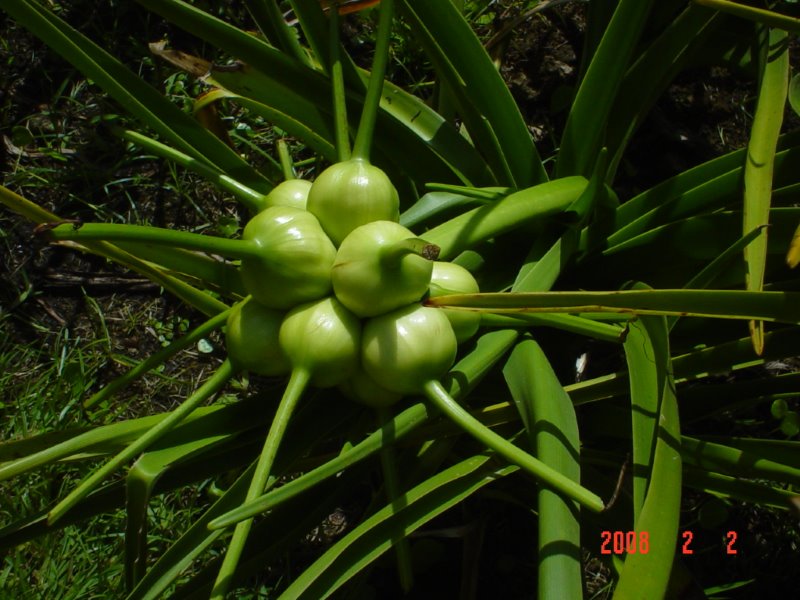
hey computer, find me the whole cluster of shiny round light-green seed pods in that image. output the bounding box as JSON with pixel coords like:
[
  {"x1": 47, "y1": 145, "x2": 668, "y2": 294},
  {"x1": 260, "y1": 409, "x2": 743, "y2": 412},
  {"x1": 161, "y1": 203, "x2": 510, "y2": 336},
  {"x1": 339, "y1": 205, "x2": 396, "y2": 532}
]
[{"x1": 226, "y1": 166, "x2": 480, "y2": 406}]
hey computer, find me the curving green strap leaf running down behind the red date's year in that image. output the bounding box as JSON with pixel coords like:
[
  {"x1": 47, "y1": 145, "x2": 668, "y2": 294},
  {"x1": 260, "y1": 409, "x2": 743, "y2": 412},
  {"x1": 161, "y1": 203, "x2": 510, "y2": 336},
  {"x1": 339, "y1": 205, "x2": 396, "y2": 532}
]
[{"x1": 614, "y1": 317, "x2": 681, "y2": 600}]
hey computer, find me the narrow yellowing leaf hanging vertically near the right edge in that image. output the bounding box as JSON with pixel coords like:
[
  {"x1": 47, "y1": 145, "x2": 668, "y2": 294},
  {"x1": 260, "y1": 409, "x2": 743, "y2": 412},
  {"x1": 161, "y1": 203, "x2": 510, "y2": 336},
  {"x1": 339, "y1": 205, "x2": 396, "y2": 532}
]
[{"x1": 743, "y1": 29, "x2": 789, "y2": 354}]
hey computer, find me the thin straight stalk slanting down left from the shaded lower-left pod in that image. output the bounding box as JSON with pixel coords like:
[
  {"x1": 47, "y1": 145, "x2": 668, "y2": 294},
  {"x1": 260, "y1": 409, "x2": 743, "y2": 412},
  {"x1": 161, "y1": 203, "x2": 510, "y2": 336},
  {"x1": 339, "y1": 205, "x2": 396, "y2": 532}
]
[{"x1": 47, "y1": 360, "x2": 234, "y2": 525}]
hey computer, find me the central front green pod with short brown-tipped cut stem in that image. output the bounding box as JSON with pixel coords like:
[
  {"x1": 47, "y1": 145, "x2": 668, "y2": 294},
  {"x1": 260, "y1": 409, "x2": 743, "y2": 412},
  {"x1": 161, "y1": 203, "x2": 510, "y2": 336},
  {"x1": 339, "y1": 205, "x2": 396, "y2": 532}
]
[{"x1": 331, "y1": 221, "x2": 439, "y2": 317}]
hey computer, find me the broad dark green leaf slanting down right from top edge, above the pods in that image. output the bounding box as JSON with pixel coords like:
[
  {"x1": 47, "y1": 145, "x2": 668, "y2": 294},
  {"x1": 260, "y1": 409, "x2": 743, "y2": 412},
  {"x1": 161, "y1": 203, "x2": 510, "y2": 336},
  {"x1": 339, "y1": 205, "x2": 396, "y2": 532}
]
[{"x1": 398, "y1": 0, "x2": 547, "y2": 188}]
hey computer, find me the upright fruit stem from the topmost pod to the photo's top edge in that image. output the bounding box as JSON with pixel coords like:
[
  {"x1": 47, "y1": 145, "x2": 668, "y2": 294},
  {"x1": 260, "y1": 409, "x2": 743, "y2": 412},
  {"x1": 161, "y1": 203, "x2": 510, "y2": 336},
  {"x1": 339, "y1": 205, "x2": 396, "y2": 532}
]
[{"x1": 353, "y1": 0, "x2": 394, "y2": 162}]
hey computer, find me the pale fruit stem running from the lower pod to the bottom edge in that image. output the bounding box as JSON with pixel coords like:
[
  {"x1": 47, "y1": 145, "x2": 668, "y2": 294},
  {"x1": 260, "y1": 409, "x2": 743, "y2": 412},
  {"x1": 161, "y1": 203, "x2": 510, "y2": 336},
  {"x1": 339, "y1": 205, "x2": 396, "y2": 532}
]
[{"x1": 211, "y1": 367, "x2": 311, "y2": 600}]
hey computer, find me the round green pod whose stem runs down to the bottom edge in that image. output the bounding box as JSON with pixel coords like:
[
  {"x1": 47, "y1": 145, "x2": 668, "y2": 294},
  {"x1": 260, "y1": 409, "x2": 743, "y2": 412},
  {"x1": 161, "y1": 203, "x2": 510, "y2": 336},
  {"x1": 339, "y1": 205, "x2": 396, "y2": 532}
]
[{"x1": 279, "y1": 297, "x2": 361, "y2": 387}]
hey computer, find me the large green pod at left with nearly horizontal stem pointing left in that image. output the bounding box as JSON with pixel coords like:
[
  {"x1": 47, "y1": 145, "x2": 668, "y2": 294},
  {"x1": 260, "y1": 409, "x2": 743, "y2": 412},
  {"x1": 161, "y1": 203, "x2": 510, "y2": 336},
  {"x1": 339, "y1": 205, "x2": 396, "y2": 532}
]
[{"x1": 242, "y1": 206, "x2": 336, "y2": 309}]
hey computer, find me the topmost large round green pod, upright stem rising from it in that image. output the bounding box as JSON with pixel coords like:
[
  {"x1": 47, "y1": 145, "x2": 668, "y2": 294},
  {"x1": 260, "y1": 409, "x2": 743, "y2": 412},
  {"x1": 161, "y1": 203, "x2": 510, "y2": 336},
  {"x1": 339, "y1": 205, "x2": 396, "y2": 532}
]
[{"x1": 307, "y1": 159, "x2": 400, "y2": 246}]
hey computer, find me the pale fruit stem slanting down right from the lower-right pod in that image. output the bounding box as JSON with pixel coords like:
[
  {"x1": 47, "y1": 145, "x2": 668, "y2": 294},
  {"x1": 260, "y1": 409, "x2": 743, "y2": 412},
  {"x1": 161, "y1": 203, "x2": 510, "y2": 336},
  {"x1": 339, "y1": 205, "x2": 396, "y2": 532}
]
[{"x1": 423, "y1": 380, "x2": 605, "y2": 513}]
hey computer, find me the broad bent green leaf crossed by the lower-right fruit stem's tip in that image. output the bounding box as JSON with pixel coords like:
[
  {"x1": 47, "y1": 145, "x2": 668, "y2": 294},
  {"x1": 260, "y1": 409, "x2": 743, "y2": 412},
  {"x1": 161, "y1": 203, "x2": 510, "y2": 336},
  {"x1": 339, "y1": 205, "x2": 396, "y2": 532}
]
[{"x1": 503, "y1": 340, "x2": 583, "y2": 598}]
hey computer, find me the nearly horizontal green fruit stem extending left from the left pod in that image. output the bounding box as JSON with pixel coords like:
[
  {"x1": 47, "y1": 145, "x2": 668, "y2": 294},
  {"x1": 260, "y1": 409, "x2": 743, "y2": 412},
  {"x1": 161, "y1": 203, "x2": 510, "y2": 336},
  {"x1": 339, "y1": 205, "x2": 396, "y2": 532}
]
[{"x1": 43, "y1": 223, "x2": 259, "y2": 258}]
